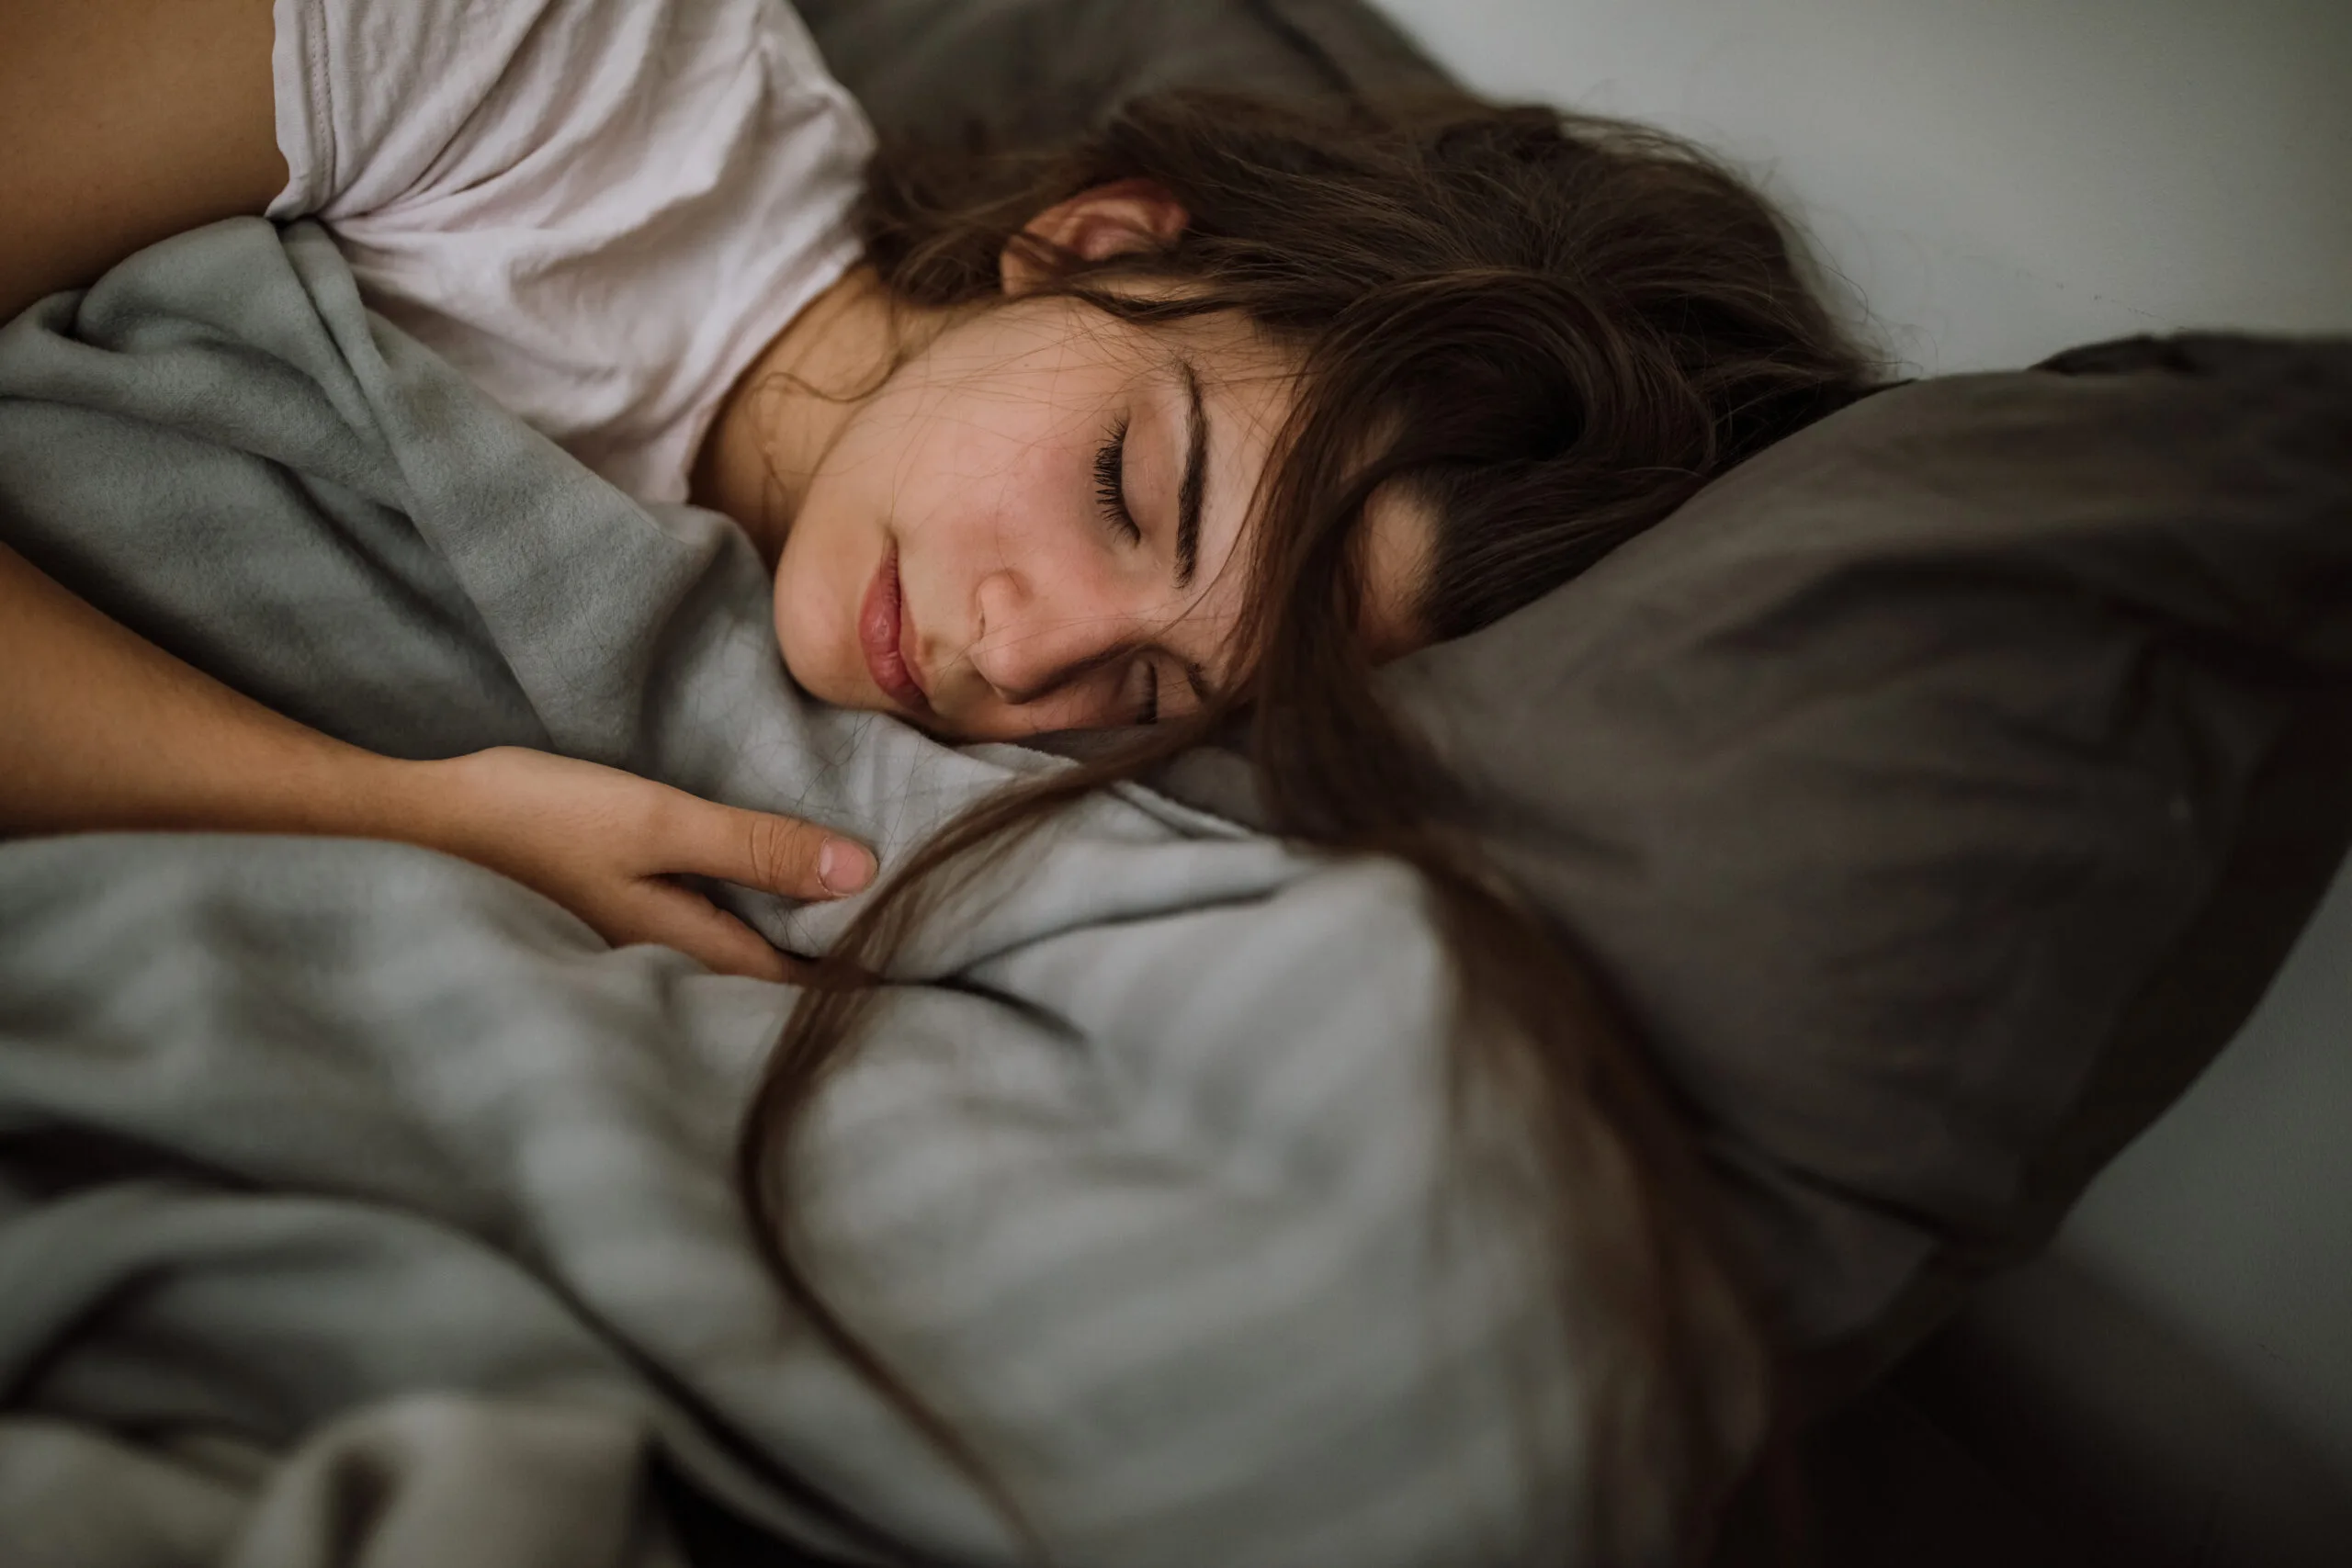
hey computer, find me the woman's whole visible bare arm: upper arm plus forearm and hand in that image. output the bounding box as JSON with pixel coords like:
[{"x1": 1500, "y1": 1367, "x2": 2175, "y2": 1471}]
[{"x1": 0, "y1": 0, "x2": 873, "y2": 978}]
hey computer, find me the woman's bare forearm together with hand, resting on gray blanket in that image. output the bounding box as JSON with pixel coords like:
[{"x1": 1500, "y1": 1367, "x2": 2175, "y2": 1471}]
[{"x1": 0, "y1": 546, "x2": 875, "y2": 980}]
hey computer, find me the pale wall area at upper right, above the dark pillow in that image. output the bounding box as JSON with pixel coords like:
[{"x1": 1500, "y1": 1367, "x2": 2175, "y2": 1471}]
[{"x1": 1376, "y1": 0, "x2": 2352, "y2": 371}]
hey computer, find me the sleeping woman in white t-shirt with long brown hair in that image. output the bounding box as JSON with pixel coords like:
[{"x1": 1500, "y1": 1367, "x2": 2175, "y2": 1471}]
[{"x1": 0, "y1": 0, "x2": 1870, "y2": 1540}]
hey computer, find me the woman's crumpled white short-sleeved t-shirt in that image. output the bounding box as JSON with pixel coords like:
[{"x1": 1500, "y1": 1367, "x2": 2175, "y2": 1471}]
[{"x1": 268, "y1": 0, "x2": 873, "y2": 501}]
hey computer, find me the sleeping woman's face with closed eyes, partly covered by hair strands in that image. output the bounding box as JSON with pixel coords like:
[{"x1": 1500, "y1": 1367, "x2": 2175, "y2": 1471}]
[{"x1": 776, "y1": 296, "x2": 1425, "y2": 740}]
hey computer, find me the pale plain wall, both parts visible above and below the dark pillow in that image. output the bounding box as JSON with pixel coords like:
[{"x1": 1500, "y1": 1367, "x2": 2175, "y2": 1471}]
[{"x1": 1376, "y1": 0, "x2": 2352, "y2": 1504}]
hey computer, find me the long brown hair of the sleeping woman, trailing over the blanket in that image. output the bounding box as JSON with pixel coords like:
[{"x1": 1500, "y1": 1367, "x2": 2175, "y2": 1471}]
[{"x1": 739, "y1": 94, "x2": 1870, "y2": 1563}]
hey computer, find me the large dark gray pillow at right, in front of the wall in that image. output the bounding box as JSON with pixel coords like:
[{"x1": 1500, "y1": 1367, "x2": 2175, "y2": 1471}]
[{"x1": 1393, "y1": 339, "x2": 2352, "y2": 1384}]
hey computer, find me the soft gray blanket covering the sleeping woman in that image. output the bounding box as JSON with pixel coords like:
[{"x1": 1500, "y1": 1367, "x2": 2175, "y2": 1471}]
[{"x1": 0, "y1": 221, "x2": 1580, "y2": 1568}]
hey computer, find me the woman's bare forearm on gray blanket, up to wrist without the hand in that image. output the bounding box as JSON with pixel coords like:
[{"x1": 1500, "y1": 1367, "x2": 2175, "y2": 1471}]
[{"x1": 0, "y1": 546, "x2": 425, "y2": 840}]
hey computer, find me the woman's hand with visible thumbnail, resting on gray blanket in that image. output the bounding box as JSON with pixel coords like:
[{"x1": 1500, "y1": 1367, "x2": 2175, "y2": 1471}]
[{"x1": 398, "y1": 745, "x2": 875, "y2": 980}]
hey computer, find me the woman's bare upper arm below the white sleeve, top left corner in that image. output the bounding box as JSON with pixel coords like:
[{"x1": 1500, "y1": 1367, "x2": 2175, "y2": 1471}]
[{"x1": 0, "y1": 0, "x2": 287, "y2": 320}]
